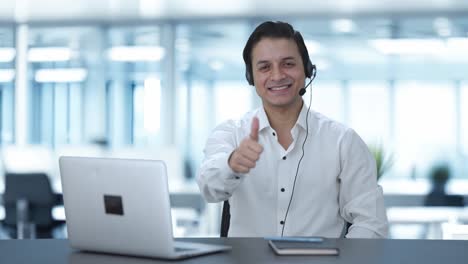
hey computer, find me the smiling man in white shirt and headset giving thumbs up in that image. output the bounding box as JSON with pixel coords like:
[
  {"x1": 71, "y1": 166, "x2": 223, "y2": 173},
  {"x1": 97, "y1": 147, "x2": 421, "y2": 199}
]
[{"x1": 197, "y1": 22, "x2": 388, "y2": 238}]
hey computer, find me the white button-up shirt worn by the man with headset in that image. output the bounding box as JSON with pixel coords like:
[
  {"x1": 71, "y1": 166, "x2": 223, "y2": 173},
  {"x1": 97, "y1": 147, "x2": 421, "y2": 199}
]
[{"x1": 197, "y1": 105, "x2": 388, "y2": 238}]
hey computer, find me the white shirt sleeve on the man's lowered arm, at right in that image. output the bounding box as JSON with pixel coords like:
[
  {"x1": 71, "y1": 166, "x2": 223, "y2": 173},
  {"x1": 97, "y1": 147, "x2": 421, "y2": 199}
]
[{"x1": 339, "y1": 129, "x2": 388, "y2": 238}]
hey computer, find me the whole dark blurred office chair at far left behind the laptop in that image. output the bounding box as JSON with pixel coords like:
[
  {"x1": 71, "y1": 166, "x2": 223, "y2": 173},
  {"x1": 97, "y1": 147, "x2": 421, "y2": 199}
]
[{"x1": 3, "y1": 172, "x2": 65, "y2": 238}]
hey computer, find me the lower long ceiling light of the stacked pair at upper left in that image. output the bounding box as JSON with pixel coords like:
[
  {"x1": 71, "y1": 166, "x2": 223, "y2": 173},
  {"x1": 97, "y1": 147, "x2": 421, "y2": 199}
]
[{"x1": 34, "y1": 68, "x2": 88, "y2": 83}]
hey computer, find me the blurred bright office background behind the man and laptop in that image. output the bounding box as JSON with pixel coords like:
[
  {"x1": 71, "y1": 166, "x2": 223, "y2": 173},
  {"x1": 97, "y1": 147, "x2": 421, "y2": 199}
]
[{"x1": 0, "y1": 0, "x2": 468, "y2": 238}]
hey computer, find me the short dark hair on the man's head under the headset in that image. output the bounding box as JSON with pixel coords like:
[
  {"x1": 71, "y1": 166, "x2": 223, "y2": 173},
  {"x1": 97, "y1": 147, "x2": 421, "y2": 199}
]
[{"x1": 242, "y1": 21, "x2": 312, "y2": 85}]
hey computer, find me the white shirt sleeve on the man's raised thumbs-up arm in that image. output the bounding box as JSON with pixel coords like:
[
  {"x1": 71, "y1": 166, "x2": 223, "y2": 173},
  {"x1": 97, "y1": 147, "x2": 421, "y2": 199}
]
[{"x1": 197, "y1": 121, "x2": 245, "y2": 203}]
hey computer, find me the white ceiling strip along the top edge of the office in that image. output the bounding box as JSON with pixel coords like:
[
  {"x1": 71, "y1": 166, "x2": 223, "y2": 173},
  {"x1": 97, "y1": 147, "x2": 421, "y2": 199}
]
[{"x1": 0, "y1": 0, "x2": 468, "y2": 22}]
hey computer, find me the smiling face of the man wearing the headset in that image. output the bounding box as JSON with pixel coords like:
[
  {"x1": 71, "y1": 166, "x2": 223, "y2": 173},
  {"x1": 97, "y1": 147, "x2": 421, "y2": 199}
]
[{"x1": 252, "y1": 38, "x2": 305, "y2": 108}]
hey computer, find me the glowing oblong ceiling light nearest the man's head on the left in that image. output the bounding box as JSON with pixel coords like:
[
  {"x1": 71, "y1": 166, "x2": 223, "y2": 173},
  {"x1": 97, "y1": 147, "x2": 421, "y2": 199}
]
[{"x1": 108, "y1": 46, "x2": 165, "y2": 62}]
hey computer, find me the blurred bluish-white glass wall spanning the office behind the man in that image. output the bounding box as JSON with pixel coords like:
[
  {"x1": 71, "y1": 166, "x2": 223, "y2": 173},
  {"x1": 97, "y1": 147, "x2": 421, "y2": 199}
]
[{"x1": 0, "y1": 16, "x2": 468, "y2": 183}]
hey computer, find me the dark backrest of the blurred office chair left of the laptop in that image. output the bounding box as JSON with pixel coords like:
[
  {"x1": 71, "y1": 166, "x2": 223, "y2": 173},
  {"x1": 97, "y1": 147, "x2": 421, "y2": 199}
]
[{"x1": 3, "y1": 172, "x2": 56, "y2": 227}]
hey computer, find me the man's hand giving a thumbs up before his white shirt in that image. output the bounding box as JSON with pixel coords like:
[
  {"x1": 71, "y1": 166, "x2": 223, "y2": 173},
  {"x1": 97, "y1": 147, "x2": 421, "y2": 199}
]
[{"x1": 228, "y1": 117, "x2": 263, "y2": 173}]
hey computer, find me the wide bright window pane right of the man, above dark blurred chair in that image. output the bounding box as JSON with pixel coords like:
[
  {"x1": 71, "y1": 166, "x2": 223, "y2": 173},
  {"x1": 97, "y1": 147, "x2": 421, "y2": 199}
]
[{"x1": 395, "y1": 81, "x2": 456, "y2": 177}]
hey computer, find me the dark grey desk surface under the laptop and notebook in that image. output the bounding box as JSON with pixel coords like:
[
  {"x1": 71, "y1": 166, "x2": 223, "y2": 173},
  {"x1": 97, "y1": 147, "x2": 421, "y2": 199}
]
[{"x1": 0, "y1": 238, "x2": 468, "y2": 264}]
